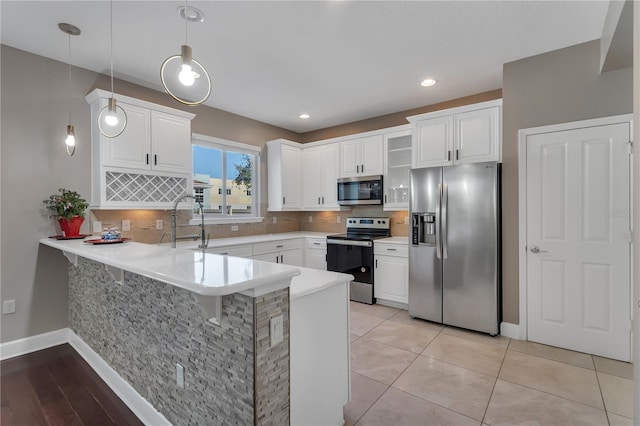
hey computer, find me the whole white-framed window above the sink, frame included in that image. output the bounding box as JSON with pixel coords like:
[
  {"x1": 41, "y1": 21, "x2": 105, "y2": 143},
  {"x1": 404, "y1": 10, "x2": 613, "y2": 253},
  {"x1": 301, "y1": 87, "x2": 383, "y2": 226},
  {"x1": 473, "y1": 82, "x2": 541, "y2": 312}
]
[{"x1": 192, "y1": 134, "x2": 262, "y2": 223}]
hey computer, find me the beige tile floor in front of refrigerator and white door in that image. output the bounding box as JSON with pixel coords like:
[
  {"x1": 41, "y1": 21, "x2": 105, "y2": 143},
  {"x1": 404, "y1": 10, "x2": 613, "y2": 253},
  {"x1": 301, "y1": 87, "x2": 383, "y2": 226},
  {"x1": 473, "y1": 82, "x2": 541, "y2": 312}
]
[{"x1": 344, "y1": 302, "x2": 633, "y2": 426}]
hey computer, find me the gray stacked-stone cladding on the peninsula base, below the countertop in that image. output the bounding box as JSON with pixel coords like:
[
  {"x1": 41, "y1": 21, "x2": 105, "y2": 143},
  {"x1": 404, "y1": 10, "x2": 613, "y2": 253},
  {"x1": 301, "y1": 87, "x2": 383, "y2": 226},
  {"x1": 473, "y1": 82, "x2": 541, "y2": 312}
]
[{"x1": 69, "y1": 257, "x2": 290, "y2": 425}]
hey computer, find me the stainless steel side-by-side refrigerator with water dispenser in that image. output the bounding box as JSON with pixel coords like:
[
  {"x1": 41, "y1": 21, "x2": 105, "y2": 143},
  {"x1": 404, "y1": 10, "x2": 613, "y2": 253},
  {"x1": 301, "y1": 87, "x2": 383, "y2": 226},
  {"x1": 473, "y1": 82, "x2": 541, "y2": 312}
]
[{"x1": 409, "y1": 163, "x2": 501, "y2": 335}]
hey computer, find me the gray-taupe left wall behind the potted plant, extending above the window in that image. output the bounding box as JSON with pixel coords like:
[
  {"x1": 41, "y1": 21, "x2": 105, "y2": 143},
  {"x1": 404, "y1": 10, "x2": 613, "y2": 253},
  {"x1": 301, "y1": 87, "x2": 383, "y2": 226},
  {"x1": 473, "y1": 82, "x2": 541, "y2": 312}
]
[{"x1": 0, "y1": 45, "x2": 300, "y2": 342}]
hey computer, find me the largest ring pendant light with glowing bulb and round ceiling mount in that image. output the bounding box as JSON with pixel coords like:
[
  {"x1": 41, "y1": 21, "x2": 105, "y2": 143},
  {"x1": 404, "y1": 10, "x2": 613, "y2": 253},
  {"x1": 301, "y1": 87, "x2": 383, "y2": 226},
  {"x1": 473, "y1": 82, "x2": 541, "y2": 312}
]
[{"x1": 160, "y1": 0, "x2": 211, "y2": 105}]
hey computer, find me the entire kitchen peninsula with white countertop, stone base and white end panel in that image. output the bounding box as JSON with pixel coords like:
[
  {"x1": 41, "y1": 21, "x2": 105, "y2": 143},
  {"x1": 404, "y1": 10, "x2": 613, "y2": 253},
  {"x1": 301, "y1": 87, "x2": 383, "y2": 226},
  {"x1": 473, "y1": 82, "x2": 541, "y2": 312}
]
[{"x1": 40, "y1": 238, "x2": 352, "y2": 425}]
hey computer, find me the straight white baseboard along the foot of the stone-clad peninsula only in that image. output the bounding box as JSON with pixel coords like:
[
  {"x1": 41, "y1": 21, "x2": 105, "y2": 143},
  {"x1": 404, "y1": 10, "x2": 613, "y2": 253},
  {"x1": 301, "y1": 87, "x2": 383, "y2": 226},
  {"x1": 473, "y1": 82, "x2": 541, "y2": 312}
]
[{"x1": 68, "y1": 330, "x2": 171, "y2": 426}]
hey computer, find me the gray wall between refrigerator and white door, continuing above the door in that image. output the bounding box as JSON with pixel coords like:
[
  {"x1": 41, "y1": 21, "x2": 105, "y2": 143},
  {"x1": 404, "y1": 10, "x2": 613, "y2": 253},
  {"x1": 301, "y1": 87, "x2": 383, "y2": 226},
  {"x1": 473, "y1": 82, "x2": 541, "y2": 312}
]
[{"x1": 502, "y1": 40, "x2": 633, "y2": 324}]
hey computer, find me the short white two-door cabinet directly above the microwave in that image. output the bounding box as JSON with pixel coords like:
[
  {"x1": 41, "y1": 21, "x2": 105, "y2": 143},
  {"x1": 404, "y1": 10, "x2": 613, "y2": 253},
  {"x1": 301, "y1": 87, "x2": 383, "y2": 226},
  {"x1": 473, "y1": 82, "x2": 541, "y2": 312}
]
[{"x1": 340, "y1": 135, "x2": 384, "y2": 177}]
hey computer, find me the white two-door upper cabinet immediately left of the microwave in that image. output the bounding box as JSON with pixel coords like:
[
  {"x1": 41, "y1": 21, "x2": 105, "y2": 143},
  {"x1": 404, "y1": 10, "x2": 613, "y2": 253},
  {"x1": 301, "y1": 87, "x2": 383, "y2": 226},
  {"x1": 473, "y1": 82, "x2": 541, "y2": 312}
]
[{"x1": 302, "y1": 143, "x2": 340, "y2": 210}]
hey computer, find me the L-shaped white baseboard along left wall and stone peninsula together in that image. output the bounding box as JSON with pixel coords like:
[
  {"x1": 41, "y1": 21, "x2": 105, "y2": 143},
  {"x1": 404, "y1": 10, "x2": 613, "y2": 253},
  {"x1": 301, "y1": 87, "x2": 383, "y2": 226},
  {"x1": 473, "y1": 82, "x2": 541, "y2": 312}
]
[{"x1": 0, "y1": 328, "x2": 171, "y2": 426}]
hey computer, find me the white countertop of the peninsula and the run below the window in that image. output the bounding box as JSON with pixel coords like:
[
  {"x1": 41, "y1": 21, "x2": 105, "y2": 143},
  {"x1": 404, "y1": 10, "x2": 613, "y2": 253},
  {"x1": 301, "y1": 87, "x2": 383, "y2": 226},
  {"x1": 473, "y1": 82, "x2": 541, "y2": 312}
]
[{"x1": 40, "y1": 236, "x2": 353, "y2": 299}]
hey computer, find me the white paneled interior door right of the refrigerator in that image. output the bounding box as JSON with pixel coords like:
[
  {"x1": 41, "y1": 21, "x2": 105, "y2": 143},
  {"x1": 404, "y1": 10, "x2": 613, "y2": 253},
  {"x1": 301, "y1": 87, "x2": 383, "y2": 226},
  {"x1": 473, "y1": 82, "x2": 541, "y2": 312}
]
[{"x1": 526, "y1": 123, "x2": 631, "y2": 361}]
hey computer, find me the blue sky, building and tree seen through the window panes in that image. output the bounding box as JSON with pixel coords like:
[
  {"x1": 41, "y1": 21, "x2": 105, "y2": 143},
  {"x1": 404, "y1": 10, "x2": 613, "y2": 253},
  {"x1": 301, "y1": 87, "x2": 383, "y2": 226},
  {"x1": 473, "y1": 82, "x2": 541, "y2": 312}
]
[{"x1": 193, "y1": 145, "x2": 256, "y2": 215}]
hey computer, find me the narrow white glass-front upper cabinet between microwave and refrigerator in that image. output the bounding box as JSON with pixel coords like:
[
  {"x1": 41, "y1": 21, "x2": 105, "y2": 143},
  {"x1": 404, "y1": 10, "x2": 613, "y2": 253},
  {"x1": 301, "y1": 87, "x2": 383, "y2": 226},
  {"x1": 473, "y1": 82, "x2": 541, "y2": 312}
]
[{"x1": 384, "y1": 126, "x2": 411, "y2": 210}]
